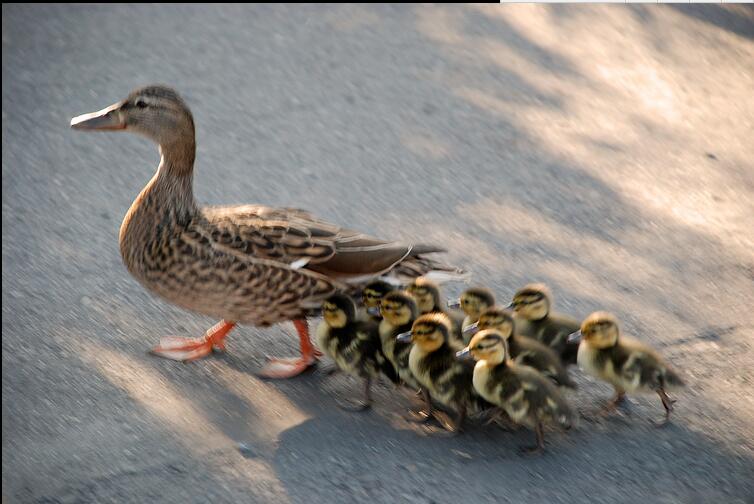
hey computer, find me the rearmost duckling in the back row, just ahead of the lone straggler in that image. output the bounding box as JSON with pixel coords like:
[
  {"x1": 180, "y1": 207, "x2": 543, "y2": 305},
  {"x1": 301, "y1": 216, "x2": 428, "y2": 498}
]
[{"x1": 508, "y1": 284, "x2": 580, "y2": 365}]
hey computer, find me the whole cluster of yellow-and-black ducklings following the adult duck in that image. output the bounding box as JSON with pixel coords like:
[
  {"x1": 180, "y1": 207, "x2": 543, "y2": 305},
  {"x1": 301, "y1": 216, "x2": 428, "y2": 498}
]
[{"x1": 317, "y1": 277, "x2": 683, "y2": 453}]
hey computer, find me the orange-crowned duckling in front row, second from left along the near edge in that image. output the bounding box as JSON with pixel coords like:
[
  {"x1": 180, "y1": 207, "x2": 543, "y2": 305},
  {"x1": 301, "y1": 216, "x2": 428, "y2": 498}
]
[{"x1": 398, "y1": 313, "x2": 480, "y2": 434}]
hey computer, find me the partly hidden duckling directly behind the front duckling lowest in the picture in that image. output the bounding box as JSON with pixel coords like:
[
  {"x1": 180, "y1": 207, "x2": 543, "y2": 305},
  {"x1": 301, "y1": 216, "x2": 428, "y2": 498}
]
[{"x1": 477, "y1": 306, "x2": 576, "y2": 389}]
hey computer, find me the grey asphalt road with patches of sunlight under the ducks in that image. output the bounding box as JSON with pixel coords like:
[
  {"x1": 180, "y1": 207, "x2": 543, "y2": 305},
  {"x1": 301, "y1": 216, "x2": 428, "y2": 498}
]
[{"x1": 2, "y1": 4, "x2": 754, "y2": 504}]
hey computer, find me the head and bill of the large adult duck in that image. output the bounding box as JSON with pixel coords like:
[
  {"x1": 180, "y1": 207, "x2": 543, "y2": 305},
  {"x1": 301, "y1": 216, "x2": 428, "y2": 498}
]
[{"x1": 71, "y1": 85, "x2": 194, "y2": 148}]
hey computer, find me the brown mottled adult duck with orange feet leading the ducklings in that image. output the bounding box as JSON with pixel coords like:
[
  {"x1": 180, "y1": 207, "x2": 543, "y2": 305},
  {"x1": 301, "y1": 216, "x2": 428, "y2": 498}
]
[{"x1": 71, "y1": 85, "x2": 457, "y2": 378}]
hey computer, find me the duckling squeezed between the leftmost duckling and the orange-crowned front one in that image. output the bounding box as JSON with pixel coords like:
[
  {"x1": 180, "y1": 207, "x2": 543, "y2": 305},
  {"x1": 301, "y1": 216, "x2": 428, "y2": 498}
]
[{"x1": 379, "y1": 291, "x2": 420, "y2": 390}]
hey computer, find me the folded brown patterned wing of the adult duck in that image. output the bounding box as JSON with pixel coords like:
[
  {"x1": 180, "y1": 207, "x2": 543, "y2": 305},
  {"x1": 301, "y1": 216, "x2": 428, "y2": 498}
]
[{"x1": 194, "y1": 205, "x2": 453, "y2": 283}]
